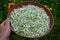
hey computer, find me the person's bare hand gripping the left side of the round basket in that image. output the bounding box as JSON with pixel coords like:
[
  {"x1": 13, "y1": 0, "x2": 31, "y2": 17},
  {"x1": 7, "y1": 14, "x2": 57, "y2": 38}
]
[{"x1": 0, "y1": 18, "x2": 11, "y2": 40}]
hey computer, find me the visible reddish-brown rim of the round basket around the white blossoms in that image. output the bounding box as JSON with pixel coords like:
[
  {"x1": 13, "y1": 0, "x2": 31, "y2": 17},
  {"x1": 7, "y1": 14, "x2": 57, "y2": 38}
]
[{"x1": 7, "y1": 2, "x2": 54, "y2": 38}]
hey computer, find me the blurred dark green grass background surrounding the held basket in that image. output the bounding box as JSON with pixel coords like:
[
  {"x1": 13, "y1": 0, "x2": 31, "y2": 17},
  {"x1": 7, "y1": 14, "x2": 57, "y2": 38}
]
[{"x1": 0, "y1": 0, "x2": 60, "y2": 40}]
